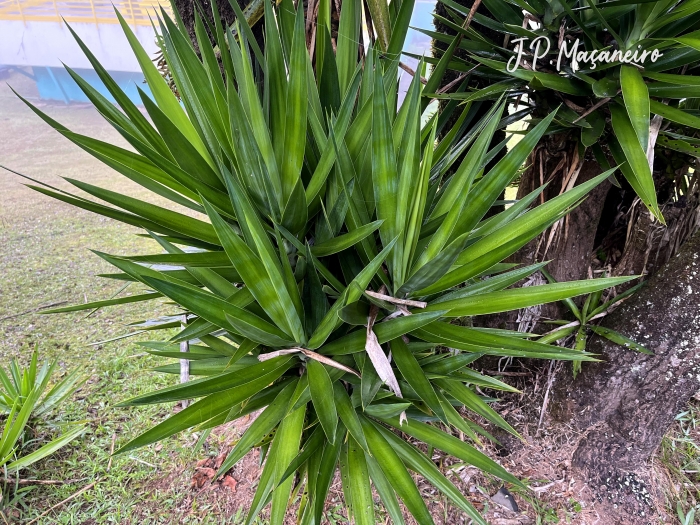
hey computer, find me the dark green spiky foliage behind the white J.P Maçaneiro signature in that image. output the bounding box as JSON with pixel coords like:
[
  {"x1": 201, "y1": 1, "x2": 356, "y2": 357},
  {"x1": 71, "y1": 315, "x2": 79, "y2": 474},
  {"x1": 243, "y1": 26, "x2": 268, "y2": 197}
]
[{"x1": 426, "y1": 0, "x2": 700, "y2": 222}]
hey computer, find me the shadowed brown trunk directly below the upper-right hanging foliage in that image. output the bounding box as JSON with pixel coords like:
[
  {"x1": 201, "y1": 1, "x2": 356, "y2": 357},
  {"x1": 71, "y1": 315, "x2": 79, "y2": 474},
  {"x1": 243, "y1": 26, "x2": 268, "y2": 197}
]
[{"x1": 490, "y1": 132, "x2": 700, "y2": 328}]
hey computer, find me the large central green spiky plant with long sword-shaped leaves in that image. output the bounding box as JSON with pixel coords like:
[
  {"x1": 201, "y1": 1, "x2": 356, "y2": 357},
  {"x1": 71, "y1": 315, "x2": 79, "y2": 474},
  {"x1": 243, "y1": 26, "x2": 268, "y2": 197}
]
[{"x1": 2, "y1": 0, "x2": 640, "y2": 524}]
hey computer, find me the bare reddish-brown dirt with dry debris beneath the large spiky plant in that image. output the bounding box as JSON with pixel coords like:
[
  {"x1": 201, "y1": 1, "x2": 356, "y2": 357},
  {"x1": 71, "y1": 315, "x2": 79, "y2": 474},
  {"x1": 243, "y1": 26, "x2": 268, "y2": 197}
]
[{"x1": 134, "y1": 406, "x2": 674, "y2": 525}]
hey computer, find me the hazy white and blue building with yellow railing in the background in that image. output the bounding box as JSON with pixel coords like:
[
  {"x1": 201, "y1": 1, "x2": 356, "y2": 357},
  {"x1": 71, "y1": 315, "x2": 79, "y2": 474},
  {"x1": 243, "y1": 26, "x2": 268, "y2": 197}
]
[{"x1": 0, "y1": 0, "x2": 170, "y2": 104}]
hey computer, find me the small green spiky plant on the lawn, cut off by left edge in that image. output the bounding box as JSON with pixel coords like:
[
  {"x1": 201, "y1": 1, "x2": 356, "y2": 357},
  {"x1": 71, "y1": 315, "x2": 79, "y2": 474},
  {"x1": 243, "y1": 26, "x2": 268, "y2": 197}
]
[{"x1": 0, "y1": 351, "x2": 85, "y2": 472}]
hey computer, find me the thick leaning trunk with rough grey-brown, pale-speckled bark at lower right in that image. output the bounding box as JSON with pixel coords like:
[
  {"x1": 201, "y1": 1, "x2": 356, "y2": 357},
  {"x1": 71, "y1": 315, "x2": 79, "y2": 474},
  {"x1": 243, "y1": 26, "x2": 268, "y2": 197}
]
[{"x1": 553, "y1": 229, "x2": 700, "y2": 478}]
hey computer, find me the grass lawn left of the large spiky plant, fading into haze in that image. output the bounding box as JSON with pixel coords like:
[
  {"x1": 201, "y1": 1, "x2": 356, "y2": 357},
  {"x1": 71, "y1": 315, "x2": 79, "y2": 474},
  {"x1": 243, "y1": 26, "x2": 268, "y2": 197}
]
[{"x1": 0, "y1": 76, "x2": 262, "y2": 524}]
